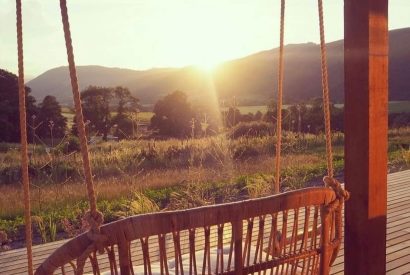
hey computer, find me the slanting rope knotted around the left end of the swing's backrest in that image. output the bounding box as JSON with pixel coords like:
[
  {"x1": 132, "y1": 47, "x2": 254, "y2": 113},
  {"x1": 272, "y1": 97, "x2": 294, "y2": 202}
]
[{"x1": 60, "y1": 0, "x2": 107, "y2": 274}]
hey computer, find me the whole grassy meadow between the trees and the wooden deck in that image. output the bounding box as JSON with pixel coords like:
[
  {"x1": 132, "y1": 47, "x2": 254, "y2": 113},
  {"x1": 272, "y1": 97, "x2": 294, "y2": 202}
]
[{"x1": 0, "y1": 128, "x2": 410, "y2": 250}]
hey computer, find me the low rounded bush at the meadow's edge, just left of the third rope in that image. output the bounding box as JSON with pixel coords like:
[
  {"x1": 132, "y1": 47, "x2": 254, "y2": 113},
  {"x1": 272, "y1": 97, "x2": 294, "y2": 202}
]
[{"x1": 229, "y1": 121, "x2": 274, "y2": 139}]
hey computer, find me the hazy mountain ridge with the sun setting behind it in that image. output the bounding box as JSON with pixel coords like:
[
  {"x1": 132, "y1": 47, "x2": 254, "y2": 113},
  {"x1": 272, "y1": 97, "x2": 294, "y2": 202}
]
[{"x1": 27, "y1": 28, "x2": 410, "y2": 105}]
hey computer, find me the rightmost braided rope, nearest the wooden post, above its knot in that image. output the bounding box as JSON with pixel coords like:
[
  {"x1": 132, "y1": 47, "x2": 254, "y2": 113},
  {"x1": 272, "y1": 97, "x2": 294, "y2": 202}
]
[{"x1": 318, "y1": 0, "x2": 334, "y2": 178}]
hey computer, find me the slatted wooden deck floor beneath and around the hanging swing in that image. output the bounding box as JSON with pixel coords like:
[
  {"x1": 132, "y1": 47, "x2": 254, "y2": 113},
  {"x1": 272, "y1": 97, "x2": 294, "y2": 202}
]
[{"x1": 0, "y1": 170, "x2": 410, "y2": 275}]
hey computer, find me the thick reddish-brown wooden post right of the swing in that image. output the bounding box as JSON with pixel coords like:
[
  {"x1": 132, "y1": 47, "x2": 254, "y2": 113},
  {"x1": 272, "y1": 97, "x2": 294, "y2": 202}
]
[{"x1": 344, "y1": 0, "x2": 388, "y2": 275}]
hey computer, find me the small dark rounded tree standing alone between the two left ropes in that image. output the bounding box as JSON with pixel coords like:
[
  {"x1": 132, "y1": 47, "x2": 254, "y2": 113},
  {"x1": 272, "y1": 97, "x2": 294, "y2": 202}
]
[{"x1": 36, "y1": 95, "x2": 67, "y2": 138}]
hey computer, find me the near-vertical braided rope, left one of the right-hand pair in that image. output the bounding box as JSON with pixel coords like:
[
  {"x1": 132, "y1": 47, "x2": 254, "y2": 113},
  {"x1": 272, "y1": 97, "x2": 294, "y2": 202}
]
[{"x1": 274, "y1": 0, "x2": 285, "y2": 194}]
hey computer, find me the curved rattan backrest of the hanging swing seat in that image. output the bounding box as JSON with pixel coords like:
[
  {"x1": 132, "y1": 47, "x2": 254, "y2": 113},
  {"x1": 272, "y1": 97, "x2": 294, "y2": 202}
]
[{"x1": 36, "y1": 187, "x2": 341, "y2": 274}]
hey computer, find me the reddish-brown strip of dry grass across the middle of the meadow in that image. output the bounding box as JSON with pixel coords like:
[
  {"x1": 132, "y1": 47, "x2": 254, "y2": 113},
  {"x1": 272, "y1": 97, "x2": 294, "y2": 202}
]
[{"x1": 0, "y1": 154, "x2": 324, "y2": 218}]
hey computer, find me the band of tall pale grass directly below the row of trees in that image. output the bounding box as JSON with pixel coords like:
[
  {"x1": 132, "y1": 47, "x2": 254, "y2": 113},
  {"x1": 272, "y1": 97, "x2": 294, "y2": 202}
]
[{"x1": 0, "y1": 133, "x2": 343, "y2": 185}]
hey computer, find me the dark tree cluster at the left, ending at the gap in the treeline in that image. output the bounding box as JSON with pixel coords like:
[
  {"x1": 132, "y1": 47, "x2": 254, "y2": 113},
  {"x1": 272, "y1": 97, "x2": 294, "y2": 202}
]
[{"x1": 0, "y1": 69, "x2": 140, "y2": 143}]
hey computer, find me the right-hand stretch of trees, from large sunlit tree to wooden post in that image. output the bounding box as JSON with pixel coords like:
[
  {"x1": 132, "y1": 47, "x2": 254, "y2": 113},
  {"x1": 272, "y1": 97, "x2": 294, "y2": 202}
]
[{"x1": 151, "y1": 91, "x2": 343, "y2": 138}]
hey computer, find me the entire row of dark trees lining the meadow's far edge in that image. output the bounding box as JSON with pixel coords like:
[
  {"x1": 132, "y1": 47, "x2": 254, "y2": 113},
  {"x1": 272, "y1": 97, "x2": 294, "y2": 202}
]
[{"x1": 0, "y1": 67, "x2": 410, "y2": 143}]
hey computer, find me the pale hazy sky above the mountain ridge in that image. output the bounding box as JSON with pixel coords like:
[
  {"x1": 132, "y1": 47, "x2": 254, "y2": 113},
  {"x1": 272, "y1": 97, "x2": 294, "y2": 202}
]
[{"x1": 0, "y1": 0, "x2": 410, "y2": 77}]
